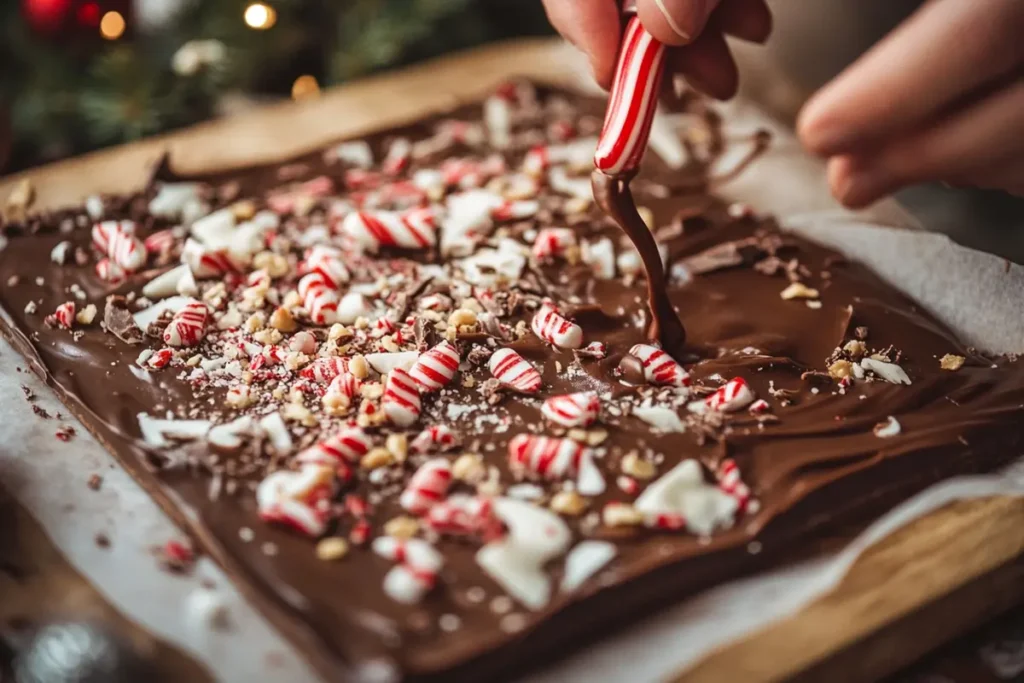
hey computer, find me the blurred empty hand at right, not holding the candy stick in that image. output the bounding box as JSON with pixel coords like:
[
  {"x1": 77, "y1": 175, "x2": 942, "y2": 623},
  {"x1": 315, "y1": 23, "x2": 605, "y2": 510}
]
[{"x1": 797, "y1": 0, "x2": 1024, "y2": 208}]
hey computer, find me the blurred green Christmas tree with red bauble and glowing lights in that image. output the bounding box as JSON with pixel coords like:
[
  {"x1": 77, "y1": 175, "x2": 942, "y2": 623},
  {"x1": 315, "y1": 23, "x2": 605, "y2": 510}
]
[{"x1": 0, "y1": 0, "x2": 550, "y2": 172}]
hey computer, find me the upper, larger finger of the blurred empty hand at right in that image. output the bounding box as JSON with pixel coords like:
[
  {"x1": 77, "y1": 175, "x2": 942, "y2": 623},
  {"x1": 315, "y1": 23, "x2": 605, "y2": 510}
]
[{"x1": 798, "y1": 0, "x2": 1024, "y2": 156}]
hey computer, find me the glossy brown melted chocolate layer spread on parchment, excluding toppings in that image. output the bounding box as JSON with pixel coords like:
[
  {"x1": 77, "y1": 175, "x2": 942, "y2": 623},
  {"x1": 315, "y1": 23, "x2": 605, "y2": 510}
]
[{"x1": 0, "y1": 87, "x2": 1024, "y2": 681}]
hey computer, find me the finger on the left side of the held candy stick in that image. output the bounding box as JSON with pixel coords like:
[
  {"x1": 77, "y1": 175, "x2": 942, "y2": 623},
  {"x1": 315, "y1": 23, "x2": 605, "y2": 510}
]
[{"x1": 544, "y1": 0, "x2": 622, "y2": 88}]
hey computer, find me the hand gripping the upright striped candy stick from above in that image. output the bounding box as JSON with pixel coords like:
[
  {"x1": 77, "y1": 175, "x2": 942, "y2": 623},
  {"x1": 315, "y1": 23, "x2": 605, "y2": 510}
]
[{"x1": 544, "y1": 0, "x2": 771, "y2": 99}]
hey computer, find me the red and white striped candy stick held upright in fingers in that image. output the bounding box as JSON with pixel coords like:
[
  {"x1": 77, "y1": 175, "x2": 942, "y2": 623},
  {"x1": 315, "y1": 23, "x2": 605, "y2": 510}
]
[{"x1": 594, "y1": 16, "x2": 666, "y2": 176}]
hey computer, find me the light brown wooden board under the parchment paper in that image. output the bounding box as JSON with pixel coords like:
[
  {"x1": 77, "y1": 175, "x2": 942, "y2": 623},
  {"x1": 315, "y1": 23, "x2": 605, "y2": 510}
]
[{"x1": 0, "y1": 41, "x2": 1024, "y2": 683}]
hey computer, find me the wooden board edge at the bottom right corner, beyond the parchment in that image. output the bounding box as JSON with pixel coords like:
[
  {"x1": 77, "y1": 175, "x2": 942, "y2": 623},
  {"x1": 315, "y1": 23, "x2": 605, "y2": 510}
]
[{"x1": 674, "y1": 497, "x2": 1024, "y2": 683}]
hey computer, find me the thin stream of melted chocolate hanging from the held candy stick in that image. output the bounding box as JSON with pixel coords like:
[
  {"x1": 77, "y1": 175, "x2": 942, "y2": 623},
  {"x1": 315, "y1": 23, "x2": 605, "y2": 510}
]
[{"x1": 591, "y1": 171, "x2": 686, "y2": 357}]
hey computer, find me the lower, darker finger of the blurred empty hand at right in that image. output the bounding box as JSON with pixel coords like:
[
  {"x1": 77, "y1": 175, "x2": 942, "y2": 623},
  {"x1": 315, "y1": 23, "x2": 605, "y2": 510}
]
[{"x1": 828, "y1": 80, "x2": 1024, "y2": 208}]
